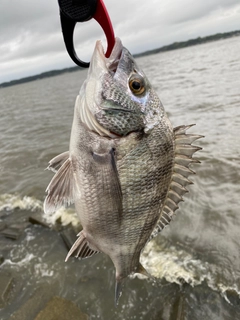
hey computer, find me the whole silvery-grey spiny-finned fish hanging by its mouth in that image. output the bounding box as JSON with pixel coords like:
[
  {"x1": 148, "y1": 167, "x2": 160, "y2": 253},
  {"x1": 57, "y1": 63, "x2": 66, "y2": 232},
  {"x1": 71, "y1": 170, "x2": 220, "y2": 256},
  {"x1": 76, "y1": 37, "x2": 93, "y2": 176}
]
[{"x1": 44, "y1": 38, "x2": 202, "y2": 305}]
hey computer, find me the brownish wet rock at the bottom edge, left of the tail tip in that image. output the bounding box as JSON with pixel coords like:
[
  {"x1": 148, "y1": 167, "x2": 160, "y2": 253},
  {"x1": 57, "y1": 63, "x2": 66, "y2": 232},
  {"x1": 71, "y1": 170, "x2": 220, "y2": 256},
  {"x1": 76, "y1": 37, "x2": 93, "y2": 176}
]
[{"x1": 34, "y1": 296, "x2": 88, "y2": 320}]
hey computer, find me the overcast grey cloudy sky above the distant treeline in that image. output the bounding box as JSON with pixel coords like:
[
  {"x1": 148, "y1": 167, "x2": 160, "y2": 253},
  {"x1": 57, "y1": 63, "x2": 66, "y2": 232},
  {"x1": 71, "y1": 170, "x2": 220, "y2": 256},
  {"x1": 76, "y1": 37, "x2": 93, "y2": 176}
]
[{"x1": 0, "y1": 0, "x2": 240, "y2": 83}]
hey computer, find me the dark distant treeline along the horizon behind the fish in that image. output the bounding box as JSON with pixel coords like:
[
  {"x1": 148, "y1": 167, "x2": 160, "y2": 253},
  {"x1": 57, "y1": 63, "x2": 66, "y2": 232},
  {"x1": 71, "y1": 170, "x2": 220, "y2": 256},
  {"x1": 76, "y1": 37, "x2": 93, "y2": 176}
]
[{"x1": 0, "y1": 30, "x2": 240, "y2": 88}]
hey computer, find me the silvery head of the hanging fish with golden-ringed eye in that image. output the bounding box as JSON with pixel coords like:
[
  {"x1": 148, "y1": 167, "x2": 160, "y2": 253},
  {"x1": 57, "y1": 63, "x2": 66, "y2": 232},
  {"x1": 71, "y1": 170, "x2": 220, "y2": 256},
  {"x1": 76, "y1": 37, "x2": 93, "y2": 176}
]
[{"x1": 79, "y1": 38, "x2": 163, "y2": 138}]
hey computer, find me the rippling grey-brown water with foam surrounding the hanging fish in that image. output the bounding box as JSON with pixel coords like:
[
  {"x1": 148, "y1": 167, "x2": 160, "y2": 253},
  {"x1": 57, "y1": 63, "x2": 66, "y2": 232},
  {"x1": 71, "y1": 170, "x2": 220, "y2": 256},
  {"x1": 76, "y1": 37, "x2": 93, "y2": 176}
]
[{"x1": 0, "y1": 37, "x2": 240, "y2": 320}]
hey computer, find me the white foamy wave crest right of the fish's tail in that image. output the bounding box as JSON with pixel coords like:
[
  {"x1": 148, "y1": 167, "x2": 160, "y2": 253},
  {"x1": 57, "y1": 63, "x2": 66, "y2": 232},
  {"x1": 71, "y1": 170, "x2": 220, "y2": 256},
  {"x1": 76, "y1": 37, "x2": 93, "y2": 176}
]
[{"x1": 140, "y1": 237, "x2": 240, "y2": 303}]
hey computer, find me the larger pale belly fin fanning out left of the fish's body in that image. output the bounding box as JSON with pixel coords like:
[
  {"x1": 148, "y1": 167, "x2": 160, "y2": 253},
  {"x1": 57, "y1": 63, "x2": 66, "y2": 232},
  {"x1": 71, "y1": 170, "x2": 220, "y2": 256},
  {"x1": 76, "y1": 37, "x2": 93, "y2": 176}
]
[{"x1": 44, "y1": 157, "x2": 76, "y2": 213}]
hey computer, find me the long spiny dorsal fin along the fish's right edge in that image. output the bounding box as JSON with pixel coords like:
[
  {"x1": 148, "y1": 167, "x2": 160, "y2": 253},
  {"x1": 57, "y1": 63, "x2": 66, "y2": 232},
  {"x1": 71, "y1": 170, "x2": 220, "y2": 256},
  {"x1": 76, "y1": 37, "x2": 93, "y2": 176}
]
[{"x1": 149, "y1": 125, "x2": 203, "y2": 241}]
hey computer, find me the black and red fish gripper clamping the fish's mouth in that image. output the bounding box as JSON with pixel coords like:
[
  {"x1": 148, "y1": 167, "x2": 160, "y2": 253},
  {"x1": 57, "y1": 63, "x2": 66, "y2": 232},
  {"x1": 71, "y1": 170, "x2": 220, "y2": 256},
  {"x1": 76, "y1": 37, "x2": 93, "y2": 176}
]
[{"x1": 58, "y1": 0, "x2": 115, "y2": 68}]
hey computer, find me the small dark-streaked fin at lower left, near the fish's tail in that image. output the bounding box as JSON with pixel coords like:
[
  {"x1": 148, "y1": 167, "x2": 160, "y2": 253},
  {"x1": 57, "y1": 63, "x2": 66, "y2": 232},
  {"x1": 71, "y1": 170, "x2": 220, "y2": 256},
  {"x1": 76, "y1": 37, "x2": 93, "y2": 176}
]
[{"x1": 65, "y1": 231, "x2": 99, "y2": 261}]
